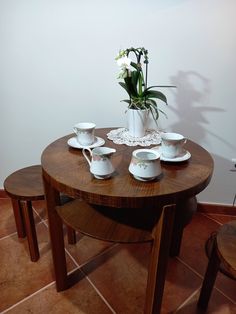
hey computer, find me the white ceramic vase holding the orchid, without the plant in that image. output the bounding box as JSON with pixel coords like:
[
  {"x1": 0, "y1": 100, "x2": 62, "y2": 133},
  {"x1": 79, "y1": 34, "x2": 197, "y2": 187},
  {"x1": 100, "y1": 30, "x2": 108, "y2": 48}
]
[{"x1": 127, "y1": 109, "x2": 149, "y2": 137}]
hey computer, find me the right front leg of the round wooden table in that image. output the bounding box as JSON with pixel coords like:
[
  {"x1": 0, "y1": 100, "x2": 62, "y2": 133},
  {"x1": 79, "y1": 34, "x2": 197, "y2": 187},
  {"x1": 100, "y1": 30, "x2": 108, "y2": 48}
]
[{"x1": 145, "y1": 205, "x2": 175, "y2": 314}]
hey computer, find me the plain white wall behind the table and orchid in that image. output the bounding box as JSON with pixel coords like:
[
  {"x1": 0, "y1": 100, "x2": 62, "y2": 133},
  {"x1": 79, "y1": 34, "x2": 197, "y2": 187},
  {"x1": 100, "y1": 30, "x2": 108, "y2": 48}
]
[{"x1": 0, "y1": 0, "x2": 236, "y2": 204}]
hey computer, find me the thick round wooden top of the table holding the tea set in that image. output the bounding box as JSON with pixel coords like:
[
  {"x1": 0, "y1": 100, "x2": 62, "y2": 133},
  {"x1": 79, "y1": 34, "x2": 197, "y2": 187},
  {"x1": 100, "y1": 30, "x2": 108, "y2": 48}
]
[{"x1": 41, "y1": 128, "x2": 213, "y2": 208}]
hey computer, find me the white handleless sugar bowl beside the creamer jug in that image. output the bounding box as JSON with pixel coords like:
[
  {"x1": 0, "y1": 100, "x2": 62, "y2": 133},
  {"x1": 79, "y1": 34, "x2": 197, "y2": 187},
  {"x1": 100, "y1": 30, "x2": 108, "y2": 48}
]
[{"x1": 129, "y1": 149, "x2": 162, "y2": 181}]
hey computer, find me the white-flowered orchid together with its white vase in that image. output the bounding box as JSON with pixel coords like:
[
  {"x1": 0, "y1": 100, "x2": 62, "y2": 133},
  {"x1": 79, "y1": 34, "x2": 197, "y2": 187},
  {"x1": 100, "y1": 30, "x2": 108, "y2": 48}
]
[{"x1": 116, "y1": 47, "x2": 175, "y2": 137}]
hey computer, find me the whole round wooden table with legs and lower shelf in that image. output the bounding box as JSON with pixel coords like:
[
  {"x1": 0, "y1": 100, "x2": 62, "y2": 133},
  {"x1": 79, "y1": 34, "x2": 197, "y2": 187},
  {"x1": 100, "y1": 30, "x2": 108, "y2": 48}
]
[{"x1": 41, "y1": 128, "x2": 213, "y2": 313}]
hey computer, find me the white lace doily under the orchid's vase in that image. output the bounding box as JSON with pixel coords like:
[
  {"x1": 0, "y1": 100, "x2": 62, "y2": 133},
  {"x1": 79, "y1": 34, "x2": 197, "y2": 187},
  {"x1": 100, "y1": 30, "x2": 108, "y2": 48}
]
[{"x1": 107, "y1": 128, "x2": 161, "y2": 146}]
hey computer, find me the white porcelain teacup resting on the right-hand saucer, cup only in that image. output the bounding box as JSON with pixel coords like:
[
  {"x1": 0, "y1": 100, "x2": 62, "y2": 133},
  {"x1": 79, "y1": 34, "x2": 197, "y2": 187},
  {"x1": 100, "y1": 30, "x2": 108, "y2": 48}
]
[{"x1": 161, "y1": 133, "x2": 187, "y2": 158}]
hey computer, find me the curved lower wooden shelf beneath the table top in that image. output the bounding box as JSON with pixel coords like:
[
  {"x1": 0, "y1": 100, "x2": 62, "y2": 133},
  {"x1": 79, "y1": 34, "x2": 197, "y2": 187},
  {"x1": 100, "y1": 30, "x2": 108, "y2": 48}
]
[{"x1": 56, "y1": 199, "x2": 154, "y2": 243}]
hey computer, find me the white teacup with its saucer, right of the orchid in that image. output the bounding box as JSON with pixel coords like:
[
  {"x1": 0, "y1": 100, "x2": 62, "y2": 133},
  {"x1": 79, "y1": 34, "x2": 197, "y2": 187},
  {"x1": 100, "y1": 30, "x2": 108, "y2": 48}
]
[{"x1": 152, "y1": 132, "x2": 191, "y2": 162}]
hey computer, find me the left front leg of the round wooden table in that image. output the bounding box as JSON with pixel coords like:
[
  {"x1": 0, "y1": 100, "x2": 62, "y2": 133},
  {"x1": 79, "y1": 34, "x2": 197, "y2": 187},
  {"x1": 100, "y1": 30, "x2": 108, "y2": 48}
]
[{"x1": 43, "y1": 176, "x2": 68, "y2": 291}]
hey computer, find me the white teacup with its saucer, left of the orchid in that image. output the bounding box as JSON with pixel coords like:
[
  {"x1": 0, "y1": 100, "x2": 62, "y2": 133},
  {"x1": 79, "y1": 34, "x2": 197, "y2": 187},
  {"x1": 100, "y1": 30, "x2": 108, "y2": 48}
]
[{"x1": 67, "y1": 122, "x2": 105, "y2": 149}]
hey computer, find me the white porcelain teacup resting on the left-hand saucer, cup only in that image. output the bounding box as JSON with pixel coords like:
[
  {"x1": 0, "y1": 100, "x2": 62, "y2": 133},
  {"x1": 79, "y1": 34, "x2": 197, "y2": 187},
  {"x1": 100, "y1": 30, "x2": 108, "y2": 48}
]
[{"x1": 73, "y1": 122, "x2": 96, "y2": 146}]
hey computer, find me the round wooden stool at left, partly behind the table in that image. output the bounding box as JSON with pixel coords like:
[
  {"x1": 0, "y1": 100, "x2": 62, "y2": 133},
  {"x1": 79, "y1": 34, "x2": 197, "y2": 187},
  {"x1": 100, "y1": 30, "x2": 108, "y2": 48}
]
[{"x1": 4, "y1": 165, "x2": 76, "y2": 262}]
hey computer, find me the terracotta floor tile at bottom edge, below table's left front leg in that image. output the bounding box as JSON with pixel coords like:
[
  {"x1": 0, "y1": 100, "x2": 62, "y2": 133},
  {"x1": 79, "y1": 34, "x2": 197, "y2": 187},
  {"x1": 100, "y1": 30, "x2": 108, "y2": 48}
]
[{"x1": 5, "y1": 278, "x2": 113, "y2": 314}]
